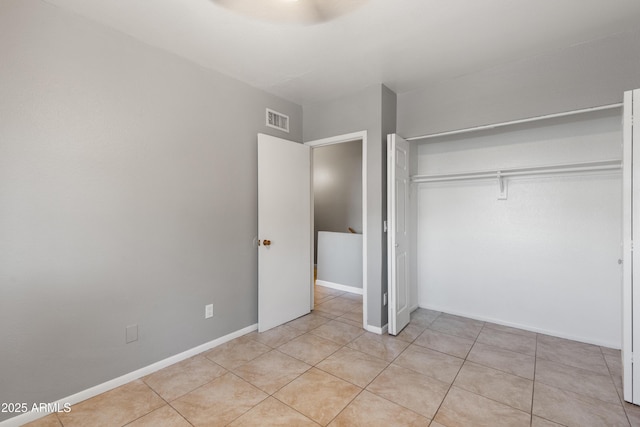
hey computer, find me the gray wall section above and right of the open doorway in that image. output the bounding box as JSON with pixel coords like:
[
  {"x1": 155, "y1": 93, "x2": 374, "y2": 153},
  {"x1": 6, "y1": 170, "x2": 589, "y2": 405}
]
[{"x1": 303, "y1": 85, "x2": 396, "y2": 327}]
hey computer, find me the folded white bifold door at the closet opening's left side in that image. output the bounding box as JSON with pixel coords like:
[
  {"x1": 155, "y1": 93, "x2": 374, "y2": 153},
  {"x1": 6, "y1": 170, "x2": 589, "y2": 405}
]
[{"x1": 387, "y1": 134, "x2": 411, "y2": 335}]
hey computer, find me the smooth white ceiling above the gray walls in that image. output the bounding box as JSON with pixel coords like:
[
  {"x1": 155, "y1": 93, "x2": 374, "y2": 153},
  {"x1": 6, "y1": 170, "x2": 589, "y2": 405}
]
[{"x1": 45, "y1": 0, "x2": 640, "y2": 104}]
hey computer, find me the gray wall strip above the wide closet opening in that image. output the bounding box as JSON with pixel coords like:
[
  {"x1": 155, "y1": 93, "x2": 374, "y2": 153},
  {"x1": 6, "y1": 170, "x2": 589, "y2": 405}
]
[{"x1": 398, "y1": 31, "x2": 640, "y2": 137}]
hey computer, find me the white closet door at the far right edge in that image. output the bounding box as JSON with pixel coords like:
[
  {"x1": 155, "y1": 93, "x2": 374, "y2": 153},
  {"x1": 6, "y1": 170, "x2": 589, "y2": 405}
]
[{"x1": 622, "y1": 89, "x2": 640, "y2": 404}]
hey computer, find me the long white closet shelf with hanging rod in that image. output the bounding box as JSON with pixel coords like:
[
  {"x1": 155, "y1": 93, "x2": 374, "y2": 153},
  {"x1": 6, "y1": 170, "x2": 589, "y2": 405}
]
[{"x1": 411, "y1": 159, "x2": 622, "y2": 183}]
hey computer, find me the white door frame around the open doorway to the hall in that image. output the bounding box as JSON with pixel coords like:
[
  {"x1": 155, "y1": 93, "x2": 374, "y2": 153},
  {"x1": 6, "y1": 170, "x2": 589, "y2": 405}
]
[{"x1": 304, "y1": 130, "x2": 368, "y2": 330}]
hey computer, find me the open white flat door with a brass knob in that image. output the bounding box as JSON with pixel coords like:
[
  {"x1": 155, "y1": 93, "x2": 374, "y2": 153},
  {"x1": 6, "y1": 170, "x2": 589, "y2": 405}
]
[{"x1": 258, "y1": 134, "x2": 313, "y2": 332}]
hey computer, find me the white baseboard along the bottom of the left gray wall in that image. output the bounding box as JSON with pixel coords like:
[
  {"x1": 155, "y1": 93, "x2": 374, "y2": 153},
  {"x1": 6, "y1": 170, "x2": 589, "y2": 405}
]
[{"x1": 0, "y1": 323, "x2": 258, "y2": 427}]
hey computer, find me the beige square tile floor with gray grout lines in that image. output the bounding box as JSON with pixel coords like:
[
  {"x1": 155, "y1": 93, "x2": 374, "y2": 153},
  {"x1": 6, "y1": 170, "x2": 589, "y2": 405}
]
[{"x1": 25, "y1": 287, "x2": 640, "y2": 427}]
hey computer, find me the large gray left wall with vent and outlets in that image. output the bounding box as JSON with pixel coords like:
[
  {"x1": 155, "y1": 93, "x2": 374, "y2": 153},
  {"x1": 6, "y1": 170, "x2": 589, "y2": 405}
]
[{"x1": 0, "y1": 0, "x2": 302, "y2": 420}]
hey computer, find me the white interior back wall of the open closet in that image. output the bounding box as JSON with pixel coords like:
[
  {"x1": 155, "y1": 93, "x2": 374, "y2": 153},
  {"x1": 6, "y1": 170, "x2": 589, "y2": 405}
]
[{"x1": 411, "y1": 106, "x2": 622, "y2": 348}]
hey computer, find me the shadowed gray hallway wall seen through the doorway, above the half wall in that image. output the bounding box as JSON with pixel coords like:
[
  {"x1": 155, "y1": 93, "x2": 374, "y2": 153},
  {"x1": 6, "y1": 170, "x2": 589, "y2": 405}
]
[{"x1": 313, "y1": 140, "x2": 362, "y2": 262}]
